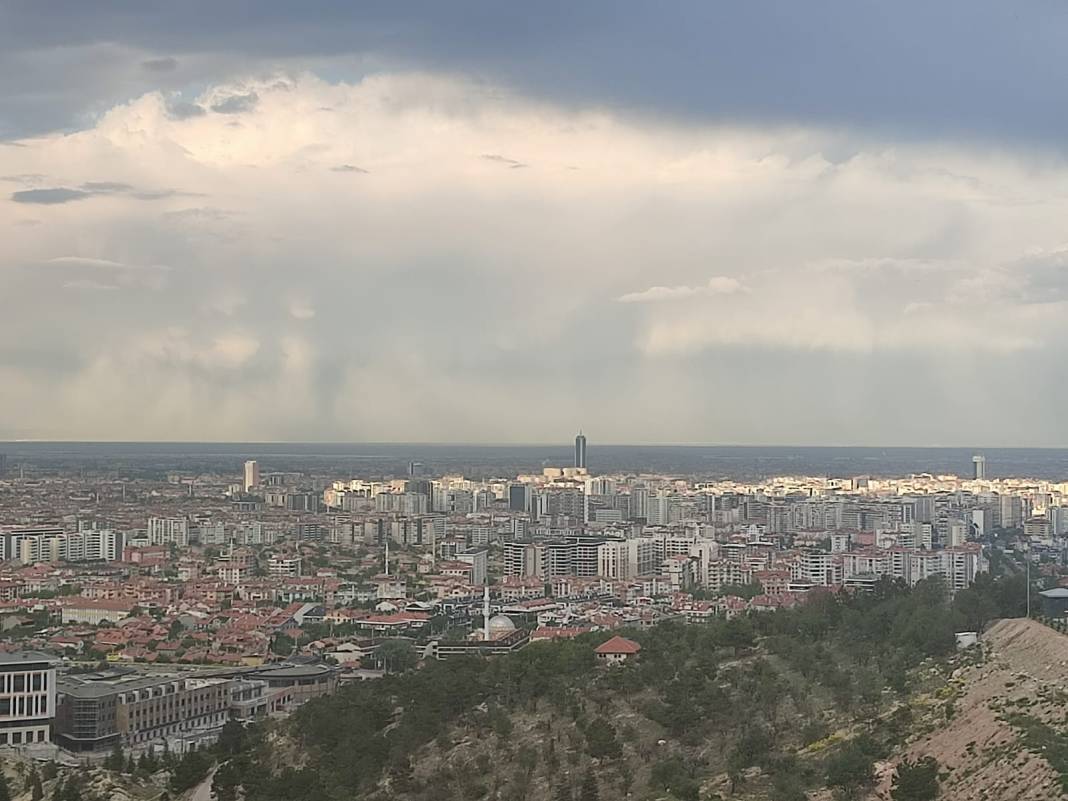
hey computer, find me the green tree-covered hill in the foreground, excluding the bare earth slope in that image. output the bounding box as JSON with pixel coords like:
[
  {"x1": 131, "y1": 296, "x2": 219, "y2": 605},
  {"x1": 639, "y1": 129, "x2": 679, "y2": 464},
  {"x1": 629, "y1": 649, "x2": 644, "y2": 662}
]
[{"x1": 216, "y1": 578, "x2": 1024, "y2": 801}]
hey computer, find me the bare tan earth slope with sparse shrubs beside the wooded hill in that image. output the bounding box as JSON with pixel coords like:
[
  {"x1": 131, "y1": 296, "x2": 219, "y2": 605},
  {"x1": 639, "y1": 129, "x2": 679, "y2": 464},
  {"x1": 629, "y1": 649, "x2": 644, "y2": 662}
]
[{"x1": 875, "y1": 618, "x2": 1068, "y2": 801}]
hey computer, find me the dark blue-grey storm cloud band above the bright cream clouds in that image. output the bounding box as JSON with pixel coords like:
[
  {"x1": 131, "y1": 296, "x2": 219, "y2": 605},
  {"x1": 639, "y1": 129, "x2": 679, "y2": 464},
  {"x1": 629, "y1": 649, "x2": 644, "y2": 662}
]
[{"x1": 0, "y1": 0, "x2": 1068, "y2": 144}]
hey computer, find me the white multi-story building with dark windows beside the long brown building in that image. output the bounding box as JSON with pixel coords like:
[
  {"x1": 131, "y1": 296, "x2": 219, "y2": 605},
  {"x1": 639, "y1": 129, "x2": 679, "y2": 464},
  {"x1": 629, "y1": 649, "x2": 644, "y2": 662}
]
[{"x1": 0, "y1": 651, "x2": 56, "y2": 747}]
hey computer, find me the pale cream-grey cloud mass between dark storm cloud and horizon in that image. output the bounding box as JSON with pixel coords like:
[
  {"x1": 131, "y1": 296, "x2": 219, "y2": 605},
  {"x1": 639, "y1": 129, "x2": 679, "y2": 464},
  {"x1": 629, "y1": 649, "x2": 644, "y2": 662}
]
[{"x1": 6, "y1": 46, "x2": 1068, "y2": 444}]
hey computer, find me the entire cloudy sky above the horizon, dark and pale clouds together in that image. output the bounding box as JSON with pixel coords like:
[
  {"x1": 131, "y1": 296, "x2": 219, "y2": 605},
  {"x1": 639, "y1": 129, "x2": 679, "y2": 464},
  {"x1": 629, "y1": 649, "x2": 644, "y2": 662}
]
[{"x1": 0, "y1": 0, "x2": 1068, "y2": 446}]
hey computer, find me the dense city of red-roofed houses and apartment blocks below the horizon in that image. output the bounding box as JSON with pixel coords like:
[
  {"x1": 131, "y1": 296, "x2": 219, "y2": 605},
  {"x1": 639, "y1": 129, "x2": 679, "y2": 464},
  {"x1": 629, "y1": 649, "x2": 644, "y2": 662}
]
[{"x1": 0, "y1": 446, "x2": 1050, "y2": 761}]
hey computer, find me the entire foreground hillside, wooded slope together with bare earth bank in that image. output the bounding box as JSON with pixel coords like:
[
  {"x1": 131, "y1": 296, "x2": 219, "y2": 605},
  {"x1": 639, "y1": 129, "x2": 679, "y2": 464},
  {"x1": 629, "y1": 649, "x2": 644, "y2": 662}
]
[{"x1": 4, "y1": 578, "x2": 1046, "y2": 801}]
